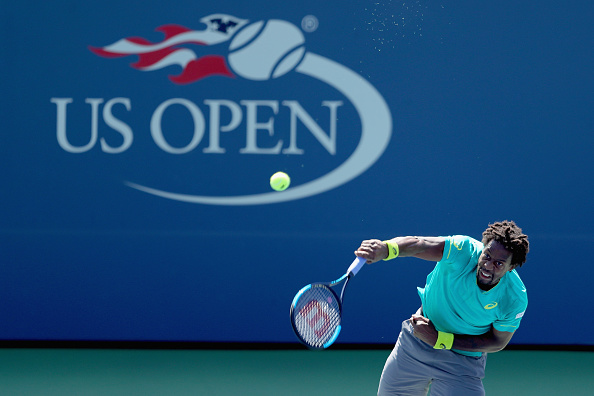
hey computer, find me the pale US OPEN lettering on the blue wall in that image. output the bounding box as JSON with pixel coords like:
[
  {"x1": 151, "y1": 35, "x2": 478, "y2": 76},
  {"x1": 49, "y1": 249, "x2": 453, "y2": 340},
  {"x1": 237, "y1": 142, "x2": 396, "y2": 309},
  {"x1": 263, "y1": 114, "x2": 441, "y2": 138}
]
[{"x1": 51, "y1": 97, "x2": 343, "y2": 155}]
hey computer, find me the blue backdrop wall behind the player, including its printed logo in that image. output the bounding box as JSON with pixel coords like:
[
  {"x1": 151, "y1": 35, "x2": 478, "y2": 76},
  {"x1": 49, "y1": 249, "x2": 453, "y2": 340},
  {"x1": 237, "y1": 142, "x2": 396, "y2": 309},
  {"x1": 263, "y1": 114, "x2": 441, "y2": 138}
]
[{"x1": 0, "y1": 0, "x2": 594, "y2": 345}]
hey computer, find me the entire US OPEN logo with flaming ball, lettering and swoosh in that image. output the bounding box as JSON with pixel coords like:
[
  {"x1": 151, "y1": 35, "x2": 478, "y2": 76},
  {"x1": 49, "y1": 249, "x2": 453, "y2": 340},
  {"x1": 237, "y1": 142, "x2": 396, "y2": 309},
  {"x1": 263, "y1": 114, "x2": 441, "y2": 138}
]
[{"x1": 51, "y1": 14, "x2": 392, "y2": 205}]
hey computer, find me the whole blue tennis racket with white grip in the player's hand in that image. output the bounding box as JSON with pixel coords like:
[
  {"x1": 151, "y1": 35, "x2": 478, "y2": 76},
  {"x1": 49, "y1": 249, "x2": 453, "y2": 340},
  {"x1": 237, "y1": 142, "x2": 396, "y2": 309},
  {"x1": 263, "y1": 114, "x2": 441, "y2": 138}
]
[{"x1": 291, "y1": 257, "x2": 366, "y2": 349}]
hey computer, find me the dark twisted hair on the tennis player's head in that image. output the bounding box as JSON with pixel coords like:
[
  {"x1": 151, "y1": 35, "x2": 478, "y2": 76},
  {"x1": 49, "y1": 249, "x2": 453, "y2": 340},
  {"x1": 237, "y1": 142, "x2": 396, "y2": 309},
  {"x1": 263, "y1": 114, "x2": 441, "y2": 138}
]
[{"x1": 483, "y1": 220, "x2": 529, "y2": 267}]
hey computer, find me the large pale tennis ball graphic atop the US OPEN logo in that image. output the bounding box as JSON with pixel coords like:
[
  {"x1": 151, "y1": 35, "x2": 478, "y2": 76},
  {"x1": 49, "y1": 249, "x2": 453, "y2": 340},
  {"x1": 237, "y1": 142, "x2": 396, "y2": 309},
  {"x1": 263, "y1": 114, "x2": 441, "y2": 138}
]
[{"x1": 228, "y1": 19, "x2": 305, "y2": 81}]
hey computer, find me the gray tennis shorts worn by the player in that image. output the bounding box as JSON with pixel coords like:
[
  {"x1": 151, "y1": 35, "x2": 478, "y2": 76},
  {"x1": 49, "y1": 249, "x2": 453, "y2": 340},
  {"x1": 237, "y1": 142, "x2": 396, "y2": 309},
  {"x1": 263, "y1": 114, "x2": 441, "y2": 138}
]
[{"x1": 377, "y1": 320, "x2": 487, "y2": 396}]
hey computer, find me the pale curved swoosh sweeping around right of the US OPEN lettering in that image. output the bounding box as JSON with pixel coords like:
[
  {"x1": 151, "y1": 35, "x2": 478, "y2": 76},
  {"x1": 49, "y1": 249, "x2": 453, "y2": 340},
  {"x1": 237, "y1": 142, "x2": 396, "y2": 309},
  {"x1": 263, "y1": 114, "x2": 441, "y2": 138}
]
[{"x1": 125, "y1": 52, "x2": 392, "y2": 206}]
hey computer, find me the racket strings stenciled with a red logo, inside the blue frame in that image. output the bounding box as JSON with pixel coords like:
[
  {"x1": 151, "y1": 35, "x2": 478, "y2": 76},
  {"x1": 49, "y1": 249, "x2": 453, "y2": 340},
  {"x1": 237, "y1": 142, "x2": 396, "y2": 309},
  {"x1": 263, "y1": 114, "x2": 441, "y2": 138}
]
[{"x1": 293, "y1": 286, "x2": 340, "y2": 348}]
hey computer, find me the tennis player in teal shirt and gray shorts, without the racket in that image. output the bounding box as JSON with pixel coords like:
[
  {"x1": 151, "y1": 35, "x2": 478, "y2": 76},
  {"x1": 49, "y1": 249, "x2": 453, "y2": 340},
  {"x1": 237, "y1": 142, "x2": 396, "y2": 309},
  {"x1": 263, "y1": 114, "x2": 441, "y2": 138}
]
[{"x1": 355, "y1": 221, "x2": 528, "y2": 396}]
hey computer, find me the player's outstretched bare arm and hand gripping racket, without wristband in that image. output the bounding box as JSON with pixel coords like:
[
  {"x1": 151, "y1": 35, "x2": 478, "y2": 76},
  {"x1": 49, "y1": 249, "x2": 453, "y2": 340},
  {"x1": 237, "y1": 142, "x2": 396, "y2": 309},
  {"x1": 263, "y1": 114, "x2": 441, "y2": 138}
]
[{"x1": 355, "y1": 236, "x2": 445, "y2": 264}]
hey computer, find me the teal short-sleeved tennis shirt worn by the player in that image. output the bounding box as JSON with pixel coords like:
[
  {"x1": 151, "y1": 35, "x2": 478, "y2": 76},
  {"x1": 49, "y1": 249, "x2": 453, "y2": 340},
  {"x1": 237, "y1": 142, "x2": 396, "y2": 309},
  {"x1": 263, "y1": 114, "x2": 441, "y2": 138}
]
[{"x1": 418, "y1": 235, "x2": 528, "y2": 356}]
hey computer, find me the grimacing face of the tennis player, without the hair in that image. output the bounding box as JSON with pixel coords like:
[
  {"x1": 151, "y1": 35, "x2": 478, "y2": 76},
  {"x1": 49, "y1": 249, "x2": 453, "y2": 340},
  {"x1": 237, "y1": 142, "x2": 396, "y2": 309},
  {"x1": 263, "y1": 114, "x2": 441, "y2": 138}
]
[{"x1": 476, "y1": 240, "x2": 513, "y2": 290}]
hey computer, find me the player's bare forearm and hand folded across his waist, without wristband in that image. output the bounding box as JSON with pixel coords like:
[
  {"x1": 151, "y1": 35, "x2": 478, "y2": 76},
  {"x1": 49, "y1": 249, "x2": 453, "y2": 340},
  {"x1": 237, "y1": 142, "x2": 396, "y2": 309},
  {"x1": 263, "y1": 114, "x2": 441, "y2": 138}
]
[{"x1": 410, "y1": 313, "x2": 514, "y2": 353}]
